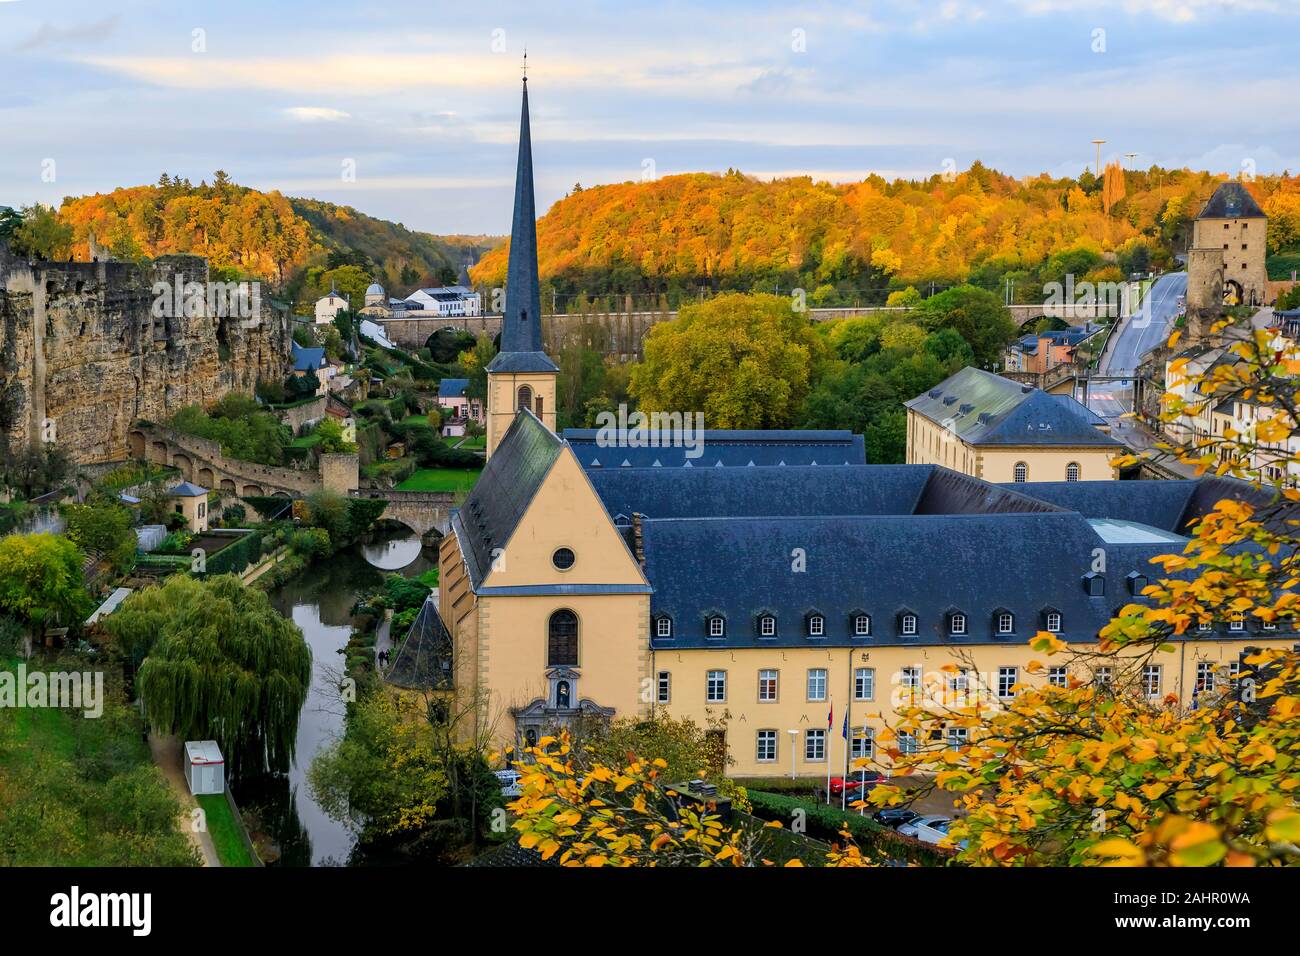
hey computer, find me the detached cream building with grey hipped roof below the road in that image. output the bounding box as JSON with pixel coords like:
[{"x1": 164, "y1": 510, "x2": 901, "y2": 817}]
[{"x1": 906, "y1": 368, "x2": 1123, "y2": 481}]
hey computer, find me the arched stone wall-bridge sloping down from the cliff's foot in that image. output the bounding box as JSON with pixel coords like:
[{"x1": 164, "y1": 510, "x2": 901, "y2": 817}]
[{"x1": 126, "y1": 421, "x2": 358, "y2": 498}]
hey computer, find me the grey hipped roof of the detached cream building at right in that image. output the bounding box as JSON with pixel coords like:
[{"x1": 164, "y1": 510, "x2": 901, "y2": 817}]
[{"x1": 905, "y1": 367, "x2": 1121, "y2": 447}]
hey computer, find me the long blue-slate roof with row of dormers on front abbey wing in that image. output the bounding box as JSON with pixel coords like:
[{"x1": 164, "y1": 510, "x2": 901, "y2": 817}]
[{"x1": 641, "y1": 511, "x2": 1170, "y2": 655}]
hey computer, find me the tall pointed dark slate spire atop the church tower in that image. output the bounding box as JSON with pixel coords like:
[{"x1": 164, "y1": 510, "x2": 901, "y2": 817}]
[{"x1": 488, "y1": 78, "x2": 556, "y2": 372}]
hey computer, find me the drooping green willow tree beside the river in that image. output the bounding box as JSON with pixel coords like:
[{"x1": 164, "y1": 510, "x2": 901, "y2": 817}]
[{"x1": 105, "y1": 575, "x2": 312, "y2": 774}]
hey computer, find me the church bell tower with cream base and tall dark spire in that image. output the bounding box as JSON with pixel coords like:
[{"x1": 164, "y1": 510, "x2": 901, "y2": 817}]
[{"x1": 486, "y1": 77, "x2": 559, "y2": 458}]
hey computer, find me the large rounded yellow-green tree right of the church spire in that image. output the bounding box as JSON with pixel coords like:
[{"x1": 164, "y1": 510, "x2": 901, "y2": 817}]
[{"x1": 631, "y1": 294, "x2": 824, "y2": 428}]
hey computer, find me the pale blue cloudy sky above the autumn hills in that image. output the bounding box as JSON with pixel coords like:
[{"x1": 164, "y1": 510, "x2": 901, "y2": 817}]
[{"x1": 0, "y1": 0, "x2": 1300, "y2": 233}]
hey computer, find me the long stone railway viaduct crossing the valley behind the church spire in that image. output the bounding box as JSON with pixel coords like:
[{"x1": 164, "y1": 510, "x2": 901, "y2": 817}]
[{"x1": 372, "y1": 303, "x2": 1114, "y2": 359}]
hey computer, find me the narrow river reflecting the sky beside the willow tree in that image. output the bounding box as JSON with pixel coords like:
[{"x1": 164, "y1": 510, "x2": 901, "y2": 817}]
[{"x1": 234, "y1": 529, "x2": 433, "y2": 866}]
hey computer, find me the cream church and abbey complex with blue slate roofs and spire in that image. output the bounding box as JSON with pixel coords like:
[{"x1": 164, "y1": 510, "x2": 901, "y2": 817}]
[{"x1": 438, "y1": 81, "x2": 1294, "y2": 777}]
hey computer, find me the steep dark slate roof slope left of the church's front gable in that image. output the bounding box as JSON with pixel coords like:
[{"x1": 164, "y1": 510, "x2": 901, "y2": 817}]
[{"x1": 451, "y1": 410, "x2": 560, "y2": 588}]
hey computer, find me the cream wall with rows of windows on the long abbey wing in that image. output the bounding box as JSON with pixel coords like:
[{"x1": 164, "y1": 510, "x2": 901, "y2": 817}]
[{"x1": 653, "y1": 635, "x2": 1290, "y2": 778}]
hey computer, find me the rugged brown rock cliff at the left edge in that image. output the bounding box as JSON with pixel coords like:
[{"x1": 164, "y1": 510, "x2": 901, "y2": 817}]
[{"x1": 0, "y1": 246, "x2": 291, "y2": 463}]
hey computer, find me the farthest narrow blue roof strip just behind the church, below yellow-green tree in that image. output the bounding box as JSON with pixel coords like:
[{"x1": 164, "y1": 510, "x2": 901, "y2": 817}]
[{"x1": 562, "y1": 428, "x2": 867, "y2": 471}]
